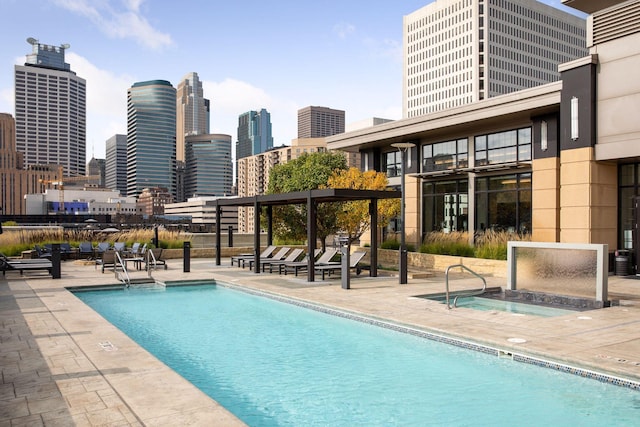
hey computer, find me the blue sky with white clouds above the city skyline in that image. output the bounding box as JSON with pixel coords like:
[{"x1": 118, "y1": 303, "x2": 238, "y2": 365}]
[{"x1": 0, "y1": 0, "x2": 575, "y2": 162}]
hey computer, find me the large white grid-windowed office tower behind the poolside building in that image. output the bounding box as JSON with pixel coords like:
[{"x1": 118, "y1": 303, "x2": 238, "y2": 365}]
[{"x1": 403, "y1": 0, "x2": 588, "y2": 118}]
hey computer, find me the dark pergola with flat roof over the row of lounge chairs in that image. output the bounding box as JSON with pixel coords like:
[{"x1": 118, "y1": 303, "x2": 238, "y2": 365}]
[{"x1": 207, "y1": 188, "x2": 402, "y2": 282}]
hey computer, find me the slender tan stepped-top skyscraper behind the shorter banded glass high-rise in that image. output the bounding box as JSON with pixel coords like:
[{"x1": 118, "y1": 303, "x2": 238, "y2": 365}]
[{"x1": 176, "y1": 73, "x2": 209, "y2": 161}]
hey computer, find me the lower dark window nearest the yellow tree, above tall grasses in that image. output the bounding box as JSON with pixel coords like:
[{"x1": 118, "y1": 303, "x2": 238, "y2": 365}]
[{"x1": 422, "y1": 179, "x2": 469, "y2": 234}]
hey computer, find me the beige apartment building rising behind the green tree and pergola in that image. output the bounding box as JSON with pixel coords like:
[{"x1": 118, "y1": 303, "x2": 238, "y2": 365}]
[{"x1": 238, "y1": 138, "x2": 360, "y2": 233}]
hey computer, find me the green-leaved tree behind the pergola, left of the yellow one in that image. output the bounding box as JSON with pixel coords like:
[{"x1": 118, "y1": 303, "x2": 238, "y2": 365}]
[{"x1": 267, "y1": 152, "x2": 347, "y2": 249}]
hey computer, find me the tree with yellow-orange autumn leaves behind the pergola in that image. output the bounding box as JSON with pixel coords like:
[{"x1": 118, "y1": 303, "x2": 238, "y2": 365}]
[{"x1": 327, "y1": 168, "x2": 400, "y2": 244}]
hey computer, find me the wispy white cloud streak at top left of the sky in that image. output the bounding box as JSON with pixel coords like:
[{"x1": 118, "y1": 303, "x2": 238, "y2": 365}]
[{"x1": 53, "y1": 0, "x2": 173, "y2": 50}]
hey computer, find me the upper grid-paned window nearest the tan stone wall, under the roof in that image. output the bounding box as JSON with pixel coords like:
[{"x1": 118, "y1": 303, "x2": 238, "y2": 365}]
[{"x1": 475, "y1": 127, "x2": 531, "y2": 166}]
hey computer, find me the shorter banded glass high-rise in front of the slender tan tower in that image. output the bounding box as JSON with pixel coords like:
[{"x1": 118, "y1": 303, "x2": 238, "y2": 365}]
[{"x1": 184, "y1": 134, "x2": 233, "y2": 198}]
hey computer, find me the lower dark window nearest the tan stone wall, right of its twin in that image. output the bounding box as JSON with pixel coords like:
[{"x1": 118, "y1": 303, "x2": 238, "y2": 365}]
[{"x1": 476, "y1": 173, "x2": 531, "y2": 233}]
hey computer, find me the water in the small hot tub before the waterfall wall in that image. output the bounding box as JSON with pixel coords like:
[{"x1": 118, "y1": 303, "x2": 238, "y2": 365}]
[{"x1": 421, "y1": 296, "x2": 576, "y2": 317}]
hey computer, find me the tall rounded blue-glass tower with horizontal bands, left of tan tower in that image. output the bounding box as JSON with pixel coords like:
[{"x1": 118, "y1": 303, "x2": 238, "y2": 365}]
[{"x1": 127, "y1": 80, "x2": 176, "y2": 198}]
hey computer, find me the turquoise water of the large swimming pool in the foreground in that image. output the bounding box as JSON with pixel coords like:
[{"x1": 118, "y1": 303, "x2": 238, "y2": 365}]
[{"x1": 76, "y1": 285, "x2": 640, "y2": 426}]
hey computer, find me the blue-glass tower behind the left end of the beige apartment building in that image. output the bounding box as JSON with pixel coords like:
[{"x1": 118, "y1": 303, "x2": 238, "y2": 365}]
[{"x1": 236, "y1": 108, "x2": 273, "y2": 159}]
